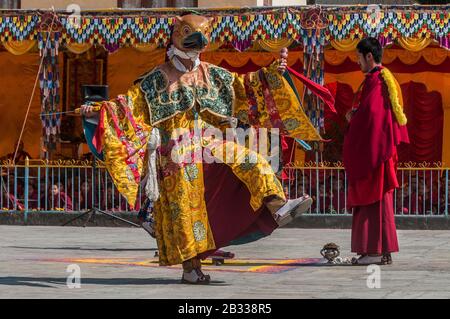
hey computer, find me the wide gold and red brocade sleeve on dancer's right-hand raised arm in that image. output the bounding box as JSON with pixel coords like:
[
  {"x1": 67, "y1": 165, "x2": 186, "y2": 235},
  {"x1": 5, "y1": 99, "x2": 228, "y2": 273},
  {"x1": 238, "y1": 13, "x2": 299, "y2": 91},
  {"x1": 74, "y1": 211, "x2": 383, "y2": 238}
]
[{"x1": 233, "y1": 63, "x2": 322, "y2": 141}]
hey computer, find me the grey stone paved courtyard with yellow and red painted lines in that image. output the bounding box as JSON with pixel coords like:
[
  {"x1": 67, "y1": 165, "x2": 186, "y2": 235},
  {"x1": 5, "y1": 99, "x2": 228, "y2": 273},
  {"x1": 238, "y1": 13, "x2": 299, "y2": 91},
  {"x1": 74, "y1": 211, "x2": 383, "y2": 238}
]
[{"x1": 0, "y1": 226, "x2": 450, "y2": 299}]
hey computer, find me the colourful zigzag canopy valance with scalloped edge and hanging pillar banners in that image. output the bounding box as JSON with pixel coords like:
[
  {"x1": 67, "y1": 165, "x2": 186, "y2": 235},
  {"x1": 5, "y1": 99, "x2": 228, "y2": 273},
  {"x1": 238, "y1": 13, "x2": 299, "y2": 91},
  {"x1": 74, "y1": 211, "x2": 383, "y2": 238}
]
[{"x1": 0, "y1": 5, "x2": 450, "y2": 159}]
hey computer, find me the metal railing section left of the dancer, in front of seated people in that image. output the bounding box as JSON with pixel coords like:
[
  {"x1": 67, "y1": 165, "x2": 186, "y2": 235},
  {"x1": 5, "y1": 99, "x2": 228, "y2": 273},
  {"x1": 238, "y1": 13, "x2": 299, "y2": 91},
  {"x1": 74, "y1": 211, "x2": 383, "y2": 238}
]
[{"x1": 0, "y1": 160, "x2": 144, "y2": 224}]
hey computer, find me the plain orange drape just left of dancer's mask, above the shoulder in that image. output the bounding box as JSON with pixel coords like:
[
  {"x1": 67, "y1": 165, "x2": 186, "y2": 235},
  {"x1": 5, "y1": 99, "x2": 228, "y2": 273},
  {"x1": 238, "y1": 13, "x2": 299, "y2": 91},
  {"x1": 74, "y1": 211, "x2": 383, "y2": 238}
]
[{"x1": 107, "y1": 47, "x2": 166, "y2": 97}]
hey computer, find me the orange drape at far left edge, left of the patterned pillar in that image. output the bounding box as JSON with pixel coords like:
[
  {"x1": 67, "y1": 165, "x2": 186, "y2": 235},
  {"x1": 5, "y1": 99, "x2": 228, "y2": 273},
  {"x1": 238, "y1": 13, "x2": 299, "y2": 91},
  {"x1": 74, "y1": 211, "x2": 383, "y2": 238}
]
[{"x1": 0, "y1": 51, "x2": 42, "y2": 158}]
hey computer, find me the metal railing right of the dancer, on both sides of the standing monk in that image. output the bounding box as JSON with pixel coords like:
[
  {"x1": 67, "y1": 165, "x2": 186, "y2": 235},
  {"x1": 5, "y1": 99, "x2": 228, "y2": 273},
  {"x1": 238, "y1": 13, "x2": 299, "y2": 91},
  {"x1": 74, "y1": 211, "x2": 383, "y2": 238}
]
[{"x1": 282, "y1": 162, "x2": 450, "y2": 217}]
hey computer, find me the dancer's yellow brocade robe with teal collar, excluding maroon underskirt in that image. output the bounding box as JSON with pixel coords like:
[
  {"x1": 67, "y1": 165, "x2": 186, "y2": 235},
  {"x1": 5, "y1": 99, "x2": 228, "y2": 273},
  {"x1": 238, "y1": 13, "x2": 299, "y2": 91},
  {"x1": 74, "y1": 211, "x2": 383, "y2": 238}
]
[{"x1": 97, "y1": 62, "x2": 321, "y2": 265}]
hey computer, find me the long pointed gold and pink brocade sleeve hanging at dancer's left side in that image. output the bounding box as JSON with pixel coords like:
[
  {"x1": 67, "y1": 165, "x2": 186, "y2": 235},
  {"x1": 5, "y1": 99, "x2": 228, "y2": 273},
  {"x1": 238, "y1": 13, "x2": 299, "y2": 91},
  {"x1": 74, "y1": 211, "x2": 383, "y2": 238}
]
[{"x1": 94, "y1": 85, "x2": 151, "y2": 207}]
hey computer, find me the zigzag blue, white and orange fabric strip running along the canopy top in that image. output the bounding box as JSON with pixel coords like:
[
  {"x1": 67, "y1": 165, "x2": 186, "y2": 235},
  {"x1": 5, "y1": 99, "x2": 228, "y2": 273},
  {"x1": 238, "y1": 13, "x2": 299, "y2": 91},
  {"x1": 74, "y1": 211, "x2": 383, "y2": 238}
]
[{"x1": 0, "y1": 6, "x2": 450, "y2": 48}]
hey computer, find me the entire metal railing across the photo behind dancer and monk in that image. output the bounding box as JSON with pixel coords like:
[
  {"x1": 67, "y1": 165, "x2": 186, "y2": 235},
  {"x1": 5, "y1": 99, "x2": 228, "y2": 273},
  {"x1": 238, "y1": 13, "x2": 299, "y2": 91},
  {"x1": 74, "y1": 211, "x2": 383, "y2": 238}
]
[{"x1": 0, "y1": 160, "x2": 449, "y2": 220}]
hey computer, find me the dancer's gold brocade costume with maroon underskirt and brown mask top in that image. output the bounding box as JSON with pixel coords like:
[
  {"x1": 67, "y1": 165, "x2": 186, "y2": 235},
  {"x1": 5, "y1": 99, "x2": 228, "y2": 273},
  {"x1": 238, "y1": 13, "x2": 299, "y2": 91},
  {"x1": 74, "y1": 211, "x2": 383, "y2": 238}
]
[{"x1": 87, "y1": 16, "x2": 321, "y2": 272}]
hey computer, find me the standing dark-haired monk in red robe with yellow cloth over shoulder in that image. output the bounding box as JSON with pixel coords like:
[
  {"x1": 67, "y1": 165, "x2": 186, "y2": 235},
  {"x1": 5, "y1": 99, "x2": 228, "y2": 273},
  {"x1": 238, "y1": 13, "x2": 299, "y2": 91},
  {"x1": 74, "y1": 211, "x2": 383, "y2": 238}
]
[{"x1": 344, "y1": 38, "x2": 409, "y2": 265}]
